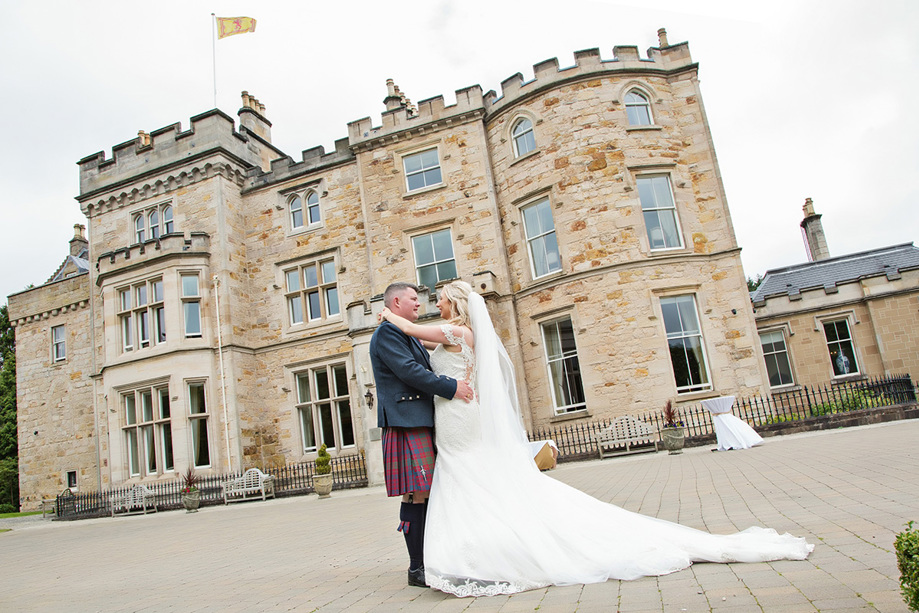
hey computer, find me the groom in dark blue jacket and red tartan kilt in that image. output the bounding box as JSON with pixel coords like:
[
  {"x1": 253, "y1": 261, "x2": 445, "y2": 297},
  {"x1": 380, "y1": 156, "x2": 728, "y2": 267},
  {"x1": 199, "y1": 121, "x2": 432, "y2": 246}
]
[{"x1": 370, "y1": 283, "x2": 472, "y2": 587}]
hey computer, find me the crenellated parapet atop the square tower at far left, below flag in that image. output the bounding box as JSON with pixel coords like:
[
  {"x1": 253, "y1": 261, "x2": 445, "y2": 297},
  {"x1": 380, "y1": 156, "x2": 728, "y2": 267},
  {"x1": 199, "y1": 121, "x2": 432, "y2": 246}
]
[{"x1": 77, "y1": 109, "x2": 283, "y2": 203}]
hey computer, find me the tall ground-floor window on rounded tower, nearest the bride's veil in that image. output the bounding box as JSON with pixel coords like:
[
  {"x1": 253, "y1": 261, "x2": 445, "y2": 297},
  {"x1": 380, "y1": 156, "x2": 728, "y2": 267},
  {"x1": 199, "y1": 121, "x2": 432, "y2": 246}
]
[{"x1": 541, "y1": 317, "x2": 587, "y2": 414}]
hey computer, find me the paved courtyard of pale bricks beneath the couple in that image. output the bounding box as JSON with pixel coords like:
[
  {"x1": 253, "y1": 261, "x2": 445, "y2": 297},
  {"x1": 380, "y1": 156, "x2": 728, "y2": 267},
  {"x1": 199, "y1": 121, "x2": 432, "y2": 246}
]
[{"x1": 0, "y1": 421, "x2": 919, "y2": 613}]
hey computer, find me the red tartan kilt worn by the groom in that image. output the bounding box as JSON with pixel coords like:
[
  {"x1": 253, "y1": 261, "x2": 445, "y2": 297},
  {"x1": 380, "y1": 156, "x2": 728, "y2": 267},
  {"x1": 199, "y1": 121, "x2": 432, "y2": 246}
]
[{"x1": 383, "y1": 427, "x2": 434, "y2": 496}]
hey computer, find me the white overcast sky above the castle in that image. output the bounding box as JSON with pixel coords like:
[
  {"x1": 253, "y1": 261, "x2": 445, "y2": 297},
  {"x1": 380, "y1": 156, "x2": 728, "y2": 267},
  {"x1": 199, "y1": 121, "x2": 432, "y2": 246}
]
[{"x1": 0, "y1": 0, "x2": 919, "y2": 303}]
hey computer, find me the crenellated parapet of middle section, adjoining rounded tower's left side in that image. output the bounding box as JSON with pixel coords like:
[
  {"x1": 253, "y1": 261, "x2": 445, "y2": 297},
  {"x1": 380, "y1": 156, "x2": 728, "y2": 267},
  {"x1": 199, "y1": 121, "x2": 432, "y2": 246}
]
[{"x1": 348, "y1": 85, "x2": 485, "y2": 153}]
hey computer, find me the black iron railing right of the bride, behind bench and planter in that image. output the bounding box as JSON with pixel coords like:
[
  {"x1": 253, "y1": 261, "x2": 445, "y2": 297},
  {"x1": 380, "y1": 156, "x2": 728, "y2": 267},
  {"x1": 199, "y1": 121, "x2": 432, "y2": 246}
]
[{"x1": 529, "y1": 375, "x2": 916, "y2": 461}]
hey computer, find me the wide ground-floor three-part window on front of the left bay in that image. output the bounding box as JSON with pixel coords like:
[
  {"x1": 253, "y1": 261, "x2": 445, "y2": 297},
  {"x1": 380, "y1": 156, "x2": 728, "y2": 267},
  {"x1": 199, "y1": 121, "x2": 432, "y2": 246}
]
[{"x1": 121, "y1": 385, "x2": 175, "y2": 477}]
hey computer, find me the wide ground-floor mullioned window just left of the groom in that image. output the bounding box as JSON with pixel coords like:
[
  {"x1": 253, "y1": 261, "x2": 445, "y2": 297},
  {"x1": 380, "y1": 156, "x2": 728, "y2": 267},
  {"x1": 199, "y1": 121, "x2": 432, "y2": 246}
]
[{"x1": 294, "y1": 364, "x2": 354, "y2": 453}]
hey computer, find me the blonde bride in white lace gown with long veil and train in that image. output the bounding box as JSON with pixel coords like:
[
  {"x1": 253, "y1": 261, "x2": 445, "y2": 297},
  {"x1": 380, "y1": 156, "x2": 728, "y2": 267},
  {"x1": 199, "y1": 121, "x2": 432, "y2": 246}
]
[{"x1": 382, "y1": 281, "x2": 814, "y2": 596}]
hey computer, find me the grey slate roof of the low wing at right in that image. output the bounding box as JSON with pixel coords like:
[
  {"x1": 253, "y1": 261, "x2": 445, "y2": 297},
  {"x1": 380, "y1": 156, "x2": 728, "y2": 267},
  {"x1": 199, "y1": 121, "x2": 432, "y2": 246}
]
[{"x1": 750, "y1": 243, "x2": 919, "y2": 304}]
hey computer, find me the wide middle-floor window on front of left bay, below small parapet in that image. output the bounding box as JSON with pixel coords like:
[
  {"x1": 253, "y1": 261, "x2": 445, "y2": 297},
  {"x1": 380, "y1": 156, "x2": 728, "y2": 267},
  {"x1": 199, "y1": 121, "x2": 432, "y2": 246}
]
[{"x1": 118, "y1": 277, "x2": 166, "y2": 351}]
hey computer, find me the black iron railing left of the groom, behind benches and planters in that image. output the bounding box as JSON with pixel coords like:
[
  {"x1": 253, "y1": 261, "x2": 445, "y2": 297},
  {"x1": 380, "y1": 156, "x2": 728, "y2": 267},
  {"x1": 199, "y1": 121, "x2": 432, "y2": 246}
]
[{"x1": 55, "y1": 454, "x2": 367, "y2": 519}]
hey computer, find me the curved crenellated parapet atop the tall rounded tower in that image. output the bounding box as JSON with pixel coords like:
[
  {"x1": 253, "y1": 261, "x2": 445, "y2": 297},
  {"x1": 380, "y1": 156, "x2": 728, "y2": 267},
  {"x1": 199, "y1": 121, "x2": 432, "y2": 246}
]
[{"x1": 485, "y1": 35, "x2": 696, "y2": 118}]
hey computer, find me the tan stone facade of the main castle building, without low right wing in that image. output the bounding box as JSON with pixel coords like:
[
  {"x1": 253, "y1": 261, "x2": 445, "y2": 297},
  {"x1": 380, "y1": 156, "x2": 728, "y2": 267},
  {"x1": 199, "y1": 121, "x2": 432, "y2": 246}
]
[{"x1": 10, "y1": 31, "x2": 766, "y2": 507}]
